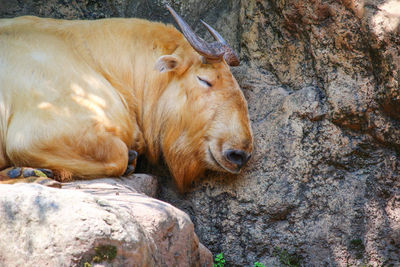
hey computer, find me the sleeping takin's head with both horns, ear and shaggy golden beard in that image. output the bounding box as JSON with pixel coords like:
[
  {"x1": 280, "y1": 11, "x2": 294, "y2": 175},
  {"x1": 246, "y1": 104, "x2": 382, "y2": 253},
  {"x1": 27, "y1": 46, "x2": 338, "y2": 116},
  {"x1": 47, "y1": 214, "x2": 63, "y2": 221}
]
[{"x1": 150, "y1": 7, "x2": 253, "y2": 191}]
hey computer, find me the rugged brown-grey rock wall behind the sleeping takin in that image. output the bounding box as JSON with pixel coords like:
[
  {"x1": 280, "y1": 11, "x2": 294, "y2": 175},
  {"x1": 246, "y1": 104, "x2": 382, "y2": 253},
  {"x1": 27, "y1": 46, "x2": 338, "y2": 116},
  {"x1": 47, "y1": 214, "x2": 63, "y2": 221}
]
[{"x1": 0, "y1": 0, "x2": 400, "y2": 266}]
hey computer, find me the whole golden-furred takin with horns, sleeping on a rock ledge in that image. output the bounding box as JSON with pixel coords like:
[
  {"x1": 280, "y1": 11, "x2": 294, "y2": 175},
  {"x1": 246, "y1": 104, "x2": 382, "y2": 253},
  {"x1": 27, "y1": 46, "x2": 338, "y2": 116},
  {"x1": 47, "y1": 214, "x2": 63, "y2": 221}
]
[{"x1": 0, "y1": 8, "x2": 252, "y2": 191}]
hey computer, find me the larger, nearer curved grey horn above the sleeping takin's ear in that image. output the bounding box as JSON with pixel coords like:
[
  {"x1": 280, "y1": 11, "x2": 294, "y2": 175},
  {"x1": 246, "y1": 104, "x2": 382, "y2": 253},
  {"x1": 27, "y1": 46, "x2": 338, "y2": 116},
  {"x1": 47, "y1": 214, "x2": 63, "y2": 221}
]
[{"x1": 166, "y1": 5, "x2": 225, "y2": 61}]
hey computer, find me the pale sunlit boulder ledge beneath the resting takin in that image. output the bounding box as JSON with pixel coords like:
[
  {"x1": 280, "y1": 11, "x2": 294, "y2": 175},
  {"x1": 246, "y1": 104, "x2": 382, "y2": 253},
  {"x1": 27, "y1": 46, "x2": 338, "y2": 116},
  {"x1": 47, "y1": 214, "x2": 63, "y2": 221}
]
[{"x1": 0, "y1": 178, "x2": 212, "y2": 266}]
